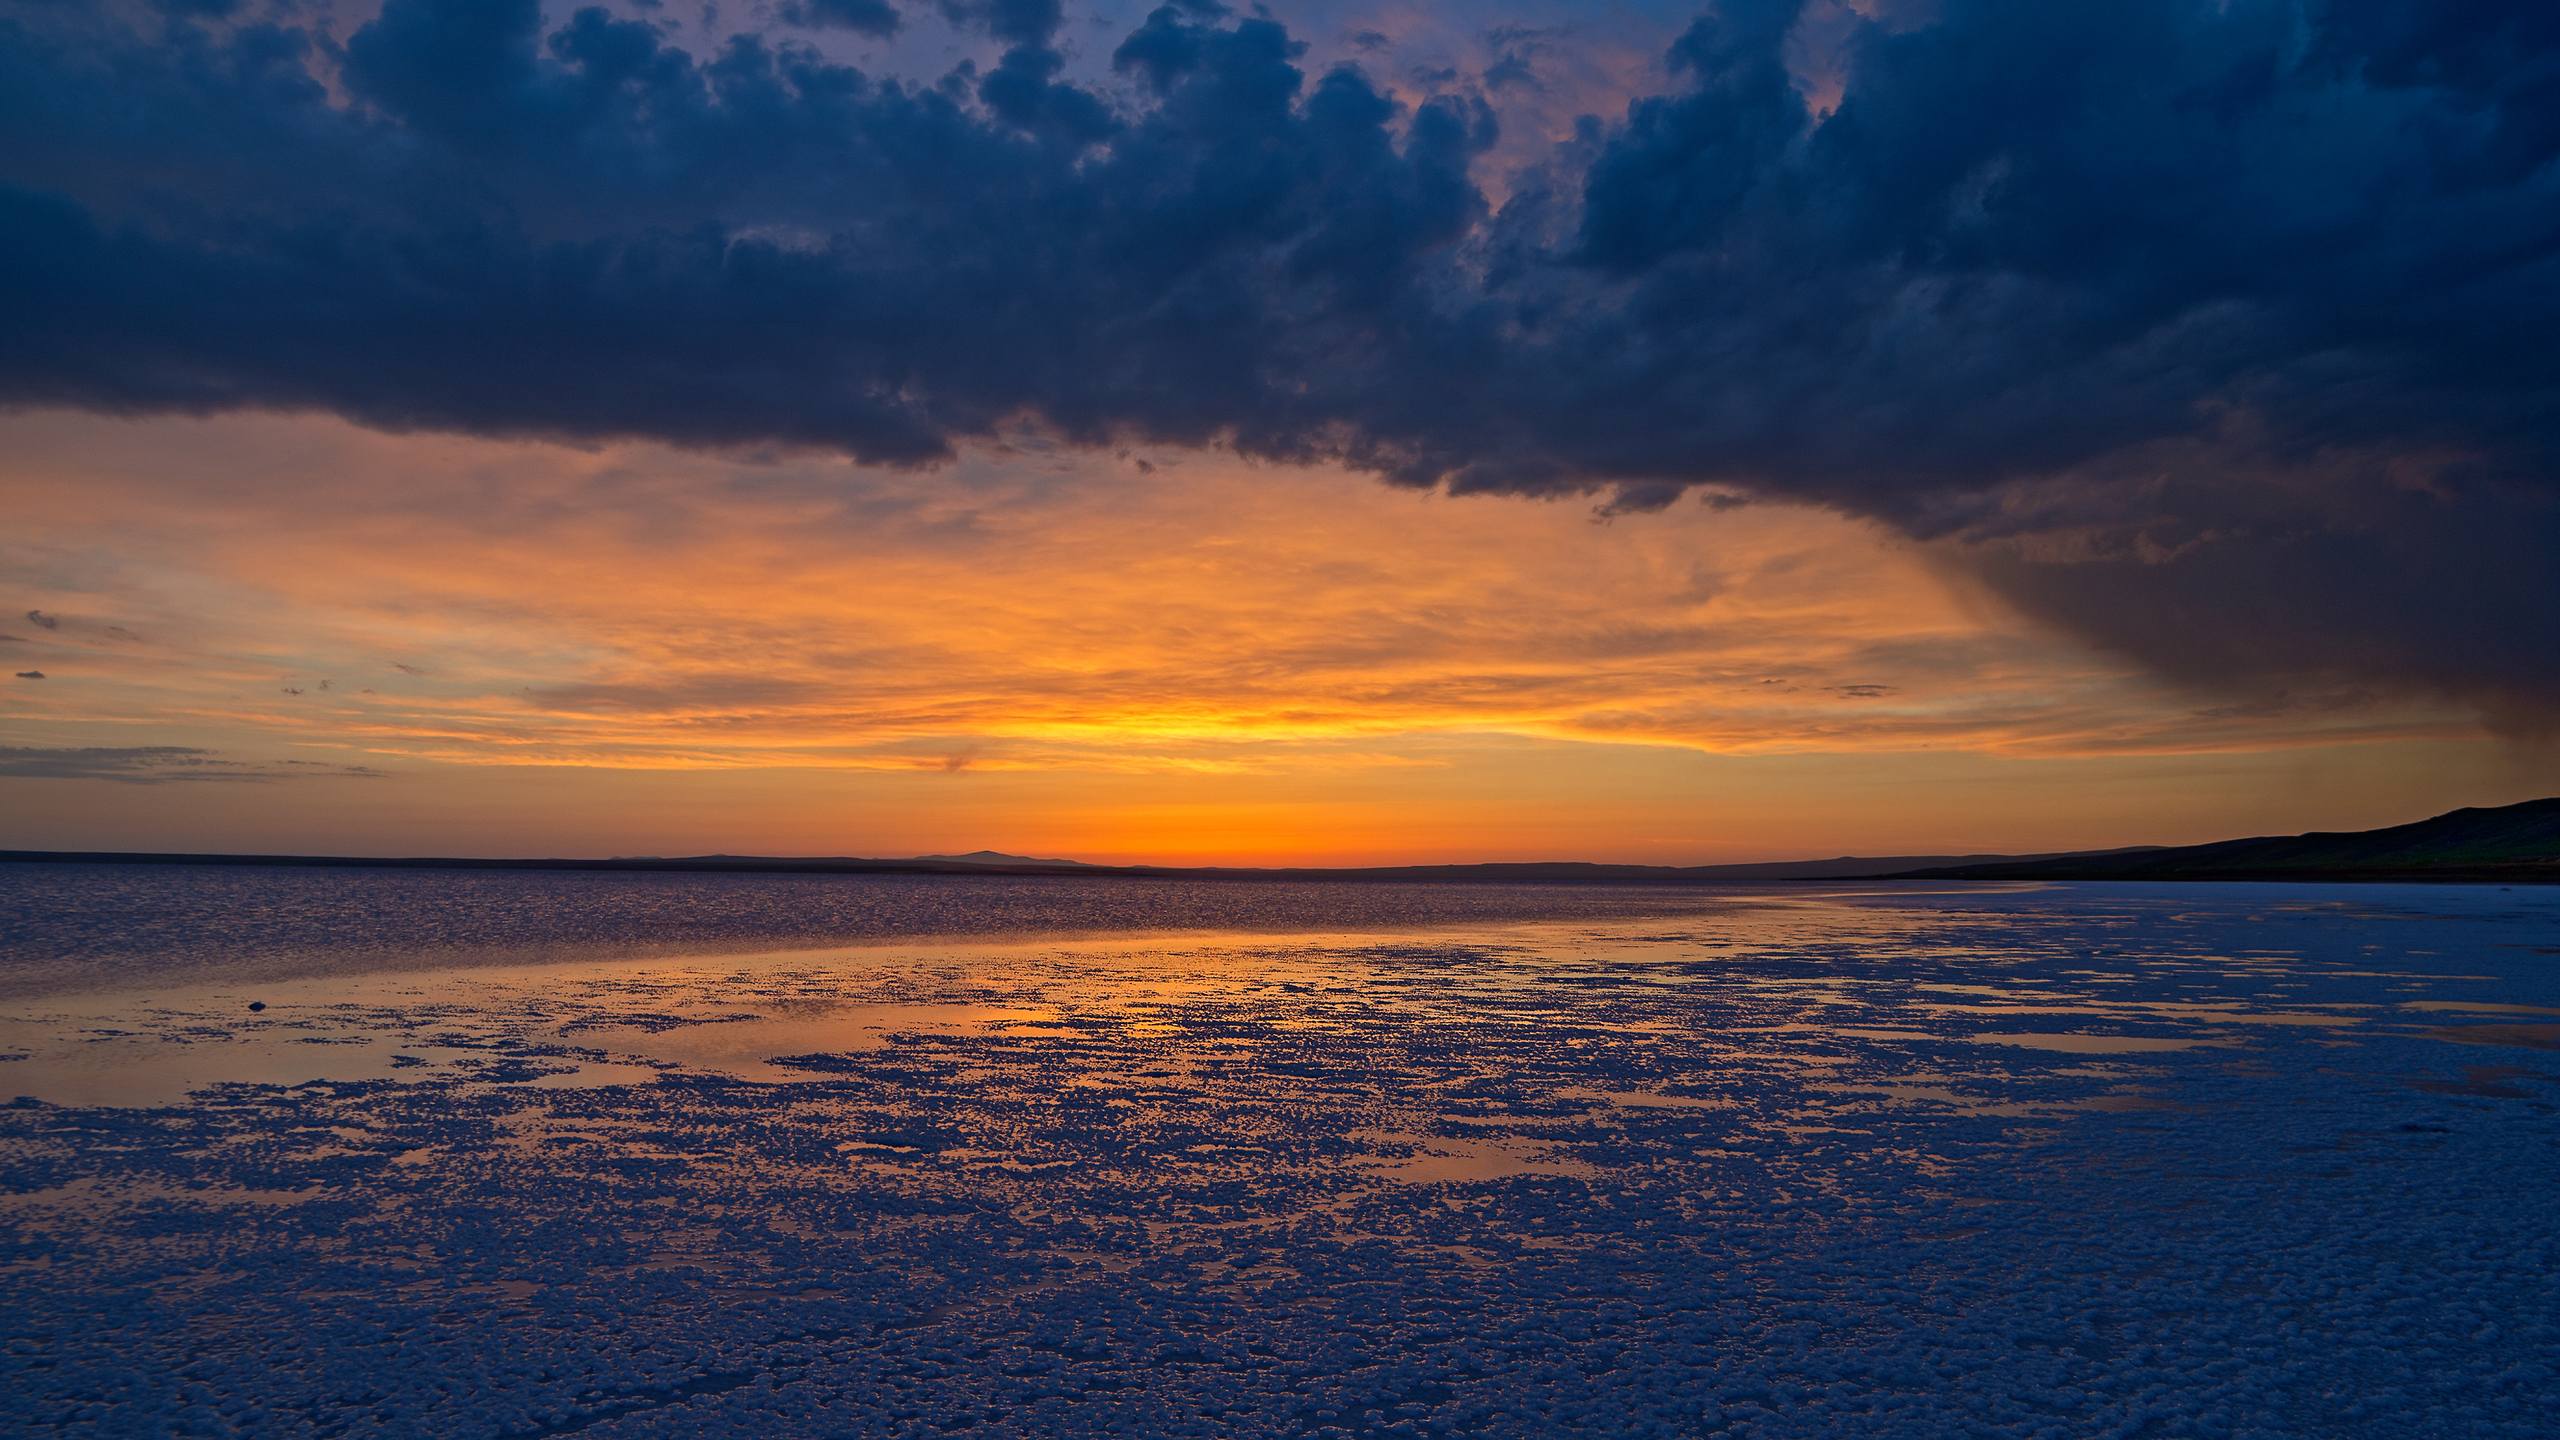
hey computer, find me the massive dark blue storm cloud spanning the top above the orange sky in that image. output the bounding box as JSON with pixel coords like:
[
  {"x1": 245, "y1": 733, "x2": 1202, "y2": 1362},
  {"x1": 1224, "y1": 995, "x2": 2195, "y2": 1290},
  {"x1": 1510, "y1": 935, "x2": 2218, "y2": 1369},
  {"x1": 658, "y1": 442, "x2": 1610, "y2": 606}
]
[{"x1": 0, "y1": 0, "x2": 2560, "y2": 725}]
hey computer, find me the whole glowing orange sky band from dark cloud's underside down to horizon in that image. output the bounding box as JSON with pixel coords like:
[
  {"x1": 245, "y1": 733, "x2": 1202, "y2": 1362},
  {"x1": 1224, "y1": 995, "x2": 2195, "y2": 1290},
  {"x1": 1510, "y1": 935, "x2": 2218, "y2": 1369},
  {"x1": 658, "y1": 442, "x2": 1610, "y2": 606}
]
[{"x1": 0, "y1": 415, "x2": 2529, "y2": 863}]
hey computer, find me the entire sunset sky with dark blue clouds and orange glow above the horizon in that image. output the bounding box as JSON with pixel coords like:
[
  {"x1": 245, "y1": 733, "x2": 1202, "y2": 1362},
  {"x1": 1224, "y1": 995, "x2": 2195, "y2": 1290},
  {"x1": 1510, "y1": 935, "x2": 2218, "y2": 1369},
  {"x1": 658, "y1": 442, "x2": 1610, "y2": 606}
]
[{"x1": 0, "y1": 0, "x2": 2560, "y2": 863}]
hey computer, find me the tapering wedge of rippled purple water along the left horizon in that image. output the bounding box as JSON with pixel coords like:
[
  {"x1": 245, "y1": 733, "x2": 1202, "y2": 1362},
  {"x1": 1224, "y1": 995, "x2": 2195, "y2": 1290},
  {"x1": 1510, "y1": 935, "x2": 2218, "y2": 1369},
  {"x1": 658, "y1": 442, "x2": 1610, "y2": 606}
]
[{"x1": 0, "y1": 861, "x2": 1761, "y2": 997}]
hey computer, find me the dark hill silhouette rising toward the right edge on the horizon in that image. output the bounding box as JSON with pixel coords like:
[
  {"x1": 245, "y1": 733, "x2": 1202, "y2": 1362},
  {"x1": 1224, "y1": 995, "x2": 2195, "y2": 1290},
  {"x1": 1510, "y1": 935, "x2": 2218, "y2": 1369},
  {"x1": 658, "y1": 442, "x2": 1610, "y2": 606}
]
[{"x1": 1897, "y1": 797, "x2": 2560, "y2": 884}]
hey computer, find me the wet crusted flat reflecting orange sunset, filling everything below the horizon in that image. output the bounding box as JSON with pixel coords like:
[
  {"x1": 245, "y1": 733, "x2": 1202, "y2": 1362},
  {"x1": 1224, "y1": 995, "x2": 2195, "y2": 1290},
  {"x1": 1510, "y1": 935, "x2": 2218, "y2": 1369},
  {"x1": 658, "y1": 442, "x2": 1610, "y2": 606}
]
[{"x1": 0, "y1": 871, "x2": 2560, "y2": 1437}]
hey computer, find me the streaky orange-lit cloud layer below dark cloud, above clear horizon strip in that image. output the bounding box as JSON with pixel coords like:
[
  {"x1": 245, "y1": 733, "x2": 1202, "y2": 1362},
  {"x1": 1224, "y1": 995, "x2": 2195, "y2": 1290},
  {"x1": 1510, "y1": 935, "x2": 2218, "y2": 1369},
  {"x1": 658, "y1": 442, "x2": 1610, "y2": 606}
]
[{"x1": 0, "y1": 415, "x2": 2468, "y2": 776}]
